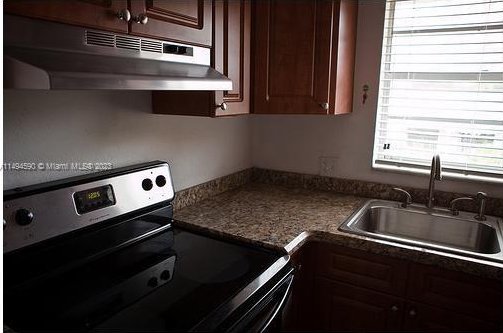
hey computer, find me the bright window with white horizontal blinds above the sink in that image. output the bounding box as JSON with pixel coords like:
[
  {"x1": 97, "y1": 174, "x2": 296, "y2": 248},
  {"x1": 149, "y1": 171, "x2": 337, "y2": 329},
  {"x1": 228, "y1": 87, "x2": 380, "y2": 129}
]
[{"x1": 373, "y1": 0, "x2": 503, "y2": 179}]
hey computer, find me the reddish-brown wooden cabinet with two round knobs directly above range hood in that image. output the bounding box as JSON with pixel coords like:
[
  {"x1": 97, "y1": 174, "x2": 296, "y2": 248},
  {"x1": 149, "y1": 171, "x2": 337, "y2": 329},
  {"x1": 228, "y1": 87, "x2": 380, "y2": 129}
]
[{"x1": 5, "y1": 0, "x2": 212, "y2": 47}]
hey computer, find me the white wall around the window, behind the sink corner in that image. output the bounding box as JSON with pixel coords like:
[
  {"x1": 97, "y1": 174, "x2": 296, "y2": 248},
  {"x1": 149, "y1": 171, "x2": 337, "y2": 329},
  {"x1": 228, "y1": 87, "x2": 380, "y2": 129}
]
[{"x1": 252, "y1": 1, "x2": 503, "y2": 197}]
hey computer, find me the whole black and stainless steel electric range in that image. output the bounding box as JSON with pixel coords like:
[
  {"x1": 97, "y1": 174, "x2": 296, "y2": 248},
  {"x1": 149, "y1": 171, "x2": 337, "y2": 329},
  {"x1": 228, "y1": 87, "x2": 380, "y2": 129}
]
[{"x1": 4, "y1": 162, "x2": 293, "y2": 332}]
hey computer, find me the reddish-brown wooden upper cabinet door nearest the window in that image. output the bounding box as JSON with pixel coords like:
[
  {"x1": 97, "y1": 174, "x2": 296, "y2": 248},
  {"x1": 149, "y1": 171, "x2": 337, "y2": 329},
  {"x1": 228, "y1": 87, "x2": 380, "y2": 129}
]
[{"x1": 253, "y1": 0, "x2": 333, "y2": 114}]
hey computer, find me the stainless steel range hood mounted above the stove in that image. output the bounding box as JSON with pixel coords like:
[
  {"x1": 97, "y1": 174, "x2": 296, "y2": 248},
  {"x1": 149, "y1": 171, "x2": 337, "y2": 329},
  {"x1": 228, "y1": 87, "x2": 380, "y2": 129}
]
[{"x1": 4, "y1": 15, "x2": 232, "y2": 90}]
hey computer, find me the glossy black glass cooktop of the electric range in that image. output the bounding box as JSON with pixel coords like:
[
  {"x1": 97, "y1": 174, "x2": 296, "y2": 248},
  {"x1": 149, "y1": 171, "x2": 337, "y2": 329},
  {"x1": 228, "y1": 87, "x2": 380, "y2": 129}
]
[{"x1": 4, "y1": 209, "x2": 281, "y2": 331}]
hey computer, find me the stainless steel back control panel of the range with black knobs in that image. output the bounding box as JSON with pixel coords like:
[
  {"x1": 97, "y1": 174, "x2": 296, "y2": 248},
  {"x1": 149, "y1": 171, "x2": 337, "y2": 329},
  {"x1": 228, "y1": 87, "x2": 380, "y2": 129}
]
[{"x1": 3, "y1": 163, "x2": 175, "y2": 253}]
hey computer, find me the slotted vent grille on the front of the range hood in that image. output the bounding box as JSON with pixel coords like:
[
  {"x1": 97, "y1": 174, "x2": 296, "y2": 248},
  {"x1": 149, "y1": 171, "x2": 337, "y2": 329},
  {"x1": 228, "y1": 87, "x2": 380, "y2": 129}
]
[{"x1": 85, "y1": 31, "x2": 163, "y2": 53}]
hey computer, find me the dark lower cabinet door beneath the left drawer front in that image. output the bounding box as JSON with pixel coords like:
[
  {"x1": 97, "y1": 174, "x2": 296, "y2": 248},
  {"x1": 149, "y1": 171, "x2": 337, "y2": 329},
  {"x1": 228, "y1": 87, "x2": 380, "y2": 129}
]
[{"x1": 311, "y1": 277, "x2": 404, "y2": 331}]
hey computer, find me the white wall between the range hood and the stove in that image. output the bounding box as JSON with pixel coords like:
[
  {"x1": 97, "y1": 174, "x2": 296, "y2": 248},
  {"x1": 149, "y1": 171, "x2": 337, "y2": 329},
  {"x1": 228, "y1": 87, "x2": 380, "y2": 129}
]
[{"x1": 4, "y1": 91, "x2": 252, "y2": 190}]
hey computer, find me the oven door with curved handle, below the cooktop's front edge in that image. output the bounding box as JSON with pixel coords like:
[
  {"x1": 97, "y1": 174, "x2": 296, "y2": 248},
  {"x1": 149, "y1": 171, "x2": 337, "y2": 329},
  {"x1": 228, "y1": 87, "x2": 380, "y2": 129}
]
[{"x1": 221, "y1": 270, "x2": 293, "y2": 332}]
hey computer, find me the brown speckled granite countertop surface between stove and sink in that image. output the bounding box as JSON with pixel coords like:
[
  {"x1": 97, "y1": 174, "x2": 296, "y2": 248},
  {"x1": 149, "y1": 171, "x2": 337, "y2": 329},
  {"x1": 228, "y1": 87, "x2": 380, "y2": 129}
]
[{"x1": 175, "y1": 183, "x2": 503, "y2": 279}]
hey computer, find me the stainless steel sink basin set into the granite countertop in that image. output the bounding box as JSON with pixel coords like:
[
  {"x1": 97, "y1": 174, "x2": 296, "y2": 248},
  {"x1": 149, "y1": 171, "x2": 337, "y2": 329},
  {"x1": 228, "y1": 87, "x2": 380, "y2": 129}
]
[{"x1": 340, "y1": 200, "x2": 503, "y2": 263}]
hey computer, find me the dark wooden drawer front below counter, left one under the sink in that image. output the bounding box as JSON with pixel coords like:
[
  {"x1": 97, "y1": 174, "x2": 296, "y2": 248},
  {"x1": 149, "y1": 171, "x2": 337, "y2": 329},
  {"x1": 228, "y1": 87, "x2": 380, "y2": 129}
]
[{"x1": 315, "y1": 243, "x2": 408, "y2": 296}]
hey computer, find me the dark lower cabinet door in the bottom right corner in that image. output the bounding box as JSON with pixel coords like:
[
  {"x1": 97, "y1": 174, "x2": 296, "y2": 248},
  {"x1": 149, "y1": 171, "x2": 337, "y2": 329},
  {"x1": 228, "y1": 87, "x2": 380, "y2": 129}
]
[{"x1": 403, "y1": 302, "x2": 498, "y2": 332}]
